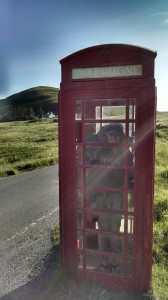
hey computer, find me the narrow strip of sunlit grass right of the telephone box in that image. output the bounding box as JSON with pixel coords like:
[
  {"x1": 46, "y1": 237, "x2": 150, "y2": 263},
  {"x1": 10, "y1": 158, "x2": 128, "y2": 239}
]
[{"x1": 152, "y1": 113, "x2": 168, "y2": 300}]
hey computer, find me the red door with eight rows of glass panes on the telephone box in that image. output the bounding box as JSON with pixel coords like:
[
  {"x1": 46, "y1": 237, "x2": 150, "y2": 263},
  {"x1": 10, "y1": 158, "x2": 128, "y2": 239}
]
[{"x1": 75, "y1": 91, "x2": 156, "y2": 286}]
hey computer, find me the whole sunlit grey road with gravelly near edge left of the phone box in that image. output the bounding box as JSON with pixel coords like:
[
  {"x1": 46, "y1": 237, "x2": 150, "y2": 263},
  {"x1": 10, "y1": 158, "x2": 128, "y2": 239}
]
[{"x1": 0, "y1": 166, "x2": 58, "y2": 297}]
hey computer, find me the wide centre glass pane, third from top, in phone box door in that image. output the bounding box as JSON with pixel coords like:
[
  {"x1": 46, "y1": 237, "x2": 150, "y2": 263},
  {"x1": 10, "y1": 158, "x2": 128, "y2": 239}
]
[{"x1": 85, "y1": 145, "x2": 125, "y2": 167}]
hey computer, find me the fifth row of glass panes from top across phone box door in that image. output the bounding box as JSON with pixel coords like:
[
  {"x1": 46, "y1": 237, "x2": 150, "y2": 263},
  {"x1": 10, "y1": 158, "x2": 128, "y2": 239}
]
[{"x1": 77, "y1": 189, "x2": 134, "y2": 212}]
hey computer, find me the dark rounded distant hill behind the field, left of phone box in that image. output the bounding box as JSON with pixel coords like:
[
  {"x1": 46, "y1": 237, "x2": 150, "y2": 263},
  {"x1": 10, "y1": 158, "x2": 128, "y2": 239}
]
[{"x1": 0, "y1": 86, "x2": 59, "y2": 119}]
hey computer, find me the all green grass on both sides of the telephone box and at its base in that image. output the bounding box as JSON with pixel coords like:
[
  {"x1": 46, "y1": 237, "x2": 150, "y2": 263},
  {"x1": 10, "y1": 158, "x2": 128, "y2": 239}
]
[{"x1": 0, "y1": 113, "x2": 168, "y2": 300}]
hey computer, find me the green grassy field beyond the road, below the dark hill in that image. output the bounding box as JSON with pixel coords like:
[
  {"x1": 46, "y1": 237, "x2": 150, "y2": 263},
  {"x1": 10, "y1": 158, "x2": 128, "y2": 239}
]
[{"x1": 0, "y1": 120, "x2": 58, "y2": 177}]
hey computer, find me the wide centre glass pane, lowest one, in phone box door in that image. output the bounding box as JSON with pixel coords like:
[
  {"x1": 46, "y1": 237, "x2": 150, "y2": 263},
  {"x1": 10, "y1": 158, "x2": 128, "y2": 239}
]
[{"x1": 86, "y1": 253, "x2": 124, "y2": 276}]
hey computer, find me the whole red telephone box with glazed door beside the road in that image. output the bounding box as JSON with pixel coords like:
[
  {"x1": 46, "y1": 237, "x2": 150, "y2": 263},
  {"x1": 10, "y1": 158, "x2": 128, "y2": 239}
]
[{"x1": 59, "y1": 44, "x2": 156, "y2": 290}]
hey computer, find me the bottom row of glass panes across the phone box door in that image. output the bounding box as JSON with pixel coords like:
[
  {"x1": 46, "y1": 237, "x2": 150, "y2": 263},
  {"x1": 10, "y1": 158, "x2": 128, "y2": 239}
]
[{"x1": 78, "y1": 251, "x2": 134, "y2": 278}]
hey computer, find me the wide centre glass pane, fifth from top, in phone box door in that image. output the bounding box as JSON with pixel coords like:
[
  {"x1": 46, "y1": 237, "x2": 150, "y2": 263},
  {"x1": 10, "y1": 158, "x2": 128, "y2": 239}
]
[{"x1": 86, "y1": 190, "x2": 124, "y2": 211}]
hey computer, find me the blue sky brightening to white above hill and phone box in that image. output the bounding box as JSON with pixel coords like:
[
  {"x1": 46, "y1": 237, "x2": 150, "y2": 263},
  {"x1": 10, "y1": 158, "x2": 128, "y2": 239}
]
[{"x1": 0, "y1": 0, "x2": 168, "y2": 111}]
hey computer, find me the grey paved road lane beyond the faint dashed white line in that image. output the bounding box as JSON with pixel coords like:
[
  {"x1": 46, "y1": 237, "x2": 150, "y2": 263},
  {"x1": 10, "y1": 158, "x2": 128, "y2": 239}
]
[{"x1": 0, "y1": 166, "x2": 58, "y2": 243}]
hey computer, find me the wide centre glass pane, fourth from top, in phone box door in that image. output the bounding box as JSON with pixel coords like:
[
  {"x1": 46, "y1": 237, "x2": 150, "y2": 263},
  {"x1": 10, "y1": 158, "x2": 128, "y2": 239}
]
[{"x1": 85, "y1": 168, "x2": 125, "y2": 189}]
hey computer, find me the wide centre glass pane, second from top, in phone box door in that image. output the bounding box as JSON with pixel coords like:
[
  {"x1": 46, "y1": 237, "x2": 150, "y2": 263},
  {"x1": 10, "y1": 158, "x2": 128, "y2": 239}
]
[{"x1": 84, "y1": 122, "x2": 125, "y2": 145}]
